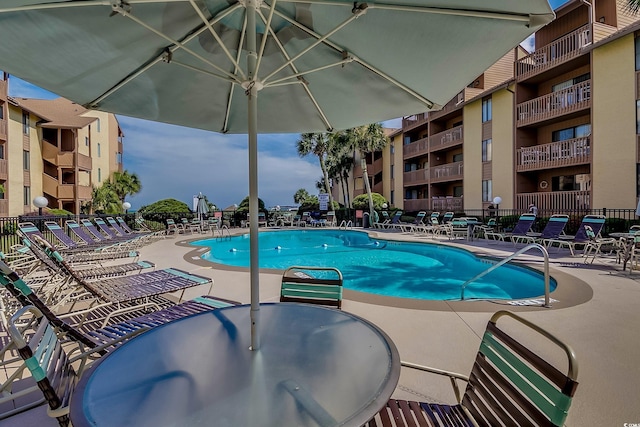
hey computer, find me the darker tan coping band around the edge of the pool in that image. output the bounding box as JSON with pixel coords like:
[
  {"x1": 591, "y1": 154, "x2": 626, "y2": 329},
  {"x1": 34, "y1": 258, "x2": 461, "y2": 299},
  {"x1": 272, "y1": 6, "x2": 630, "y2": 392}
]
[{"x1": 175, "y1": 228, "x2": 593, "y2": 313}]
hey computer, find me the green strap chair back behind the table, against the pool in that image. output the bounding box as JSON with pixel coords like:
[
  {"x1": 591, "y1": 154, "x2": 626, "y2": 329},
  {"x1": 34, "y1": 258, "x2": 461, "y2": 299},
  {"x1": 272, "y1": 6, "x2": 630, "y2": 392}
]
[{"x1": 280, "y1": 266, "x2": 342, "y2": 308}]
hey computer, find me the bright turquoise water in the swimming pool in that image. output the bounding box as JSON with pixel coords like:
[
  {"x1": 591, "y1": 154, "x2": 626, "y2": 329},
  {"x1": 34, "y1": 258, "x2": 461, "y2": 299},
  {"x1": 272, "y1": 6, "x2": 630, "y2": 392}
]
[{"x1": 194, "y1": 230, "x2": 556, "y2": 300}]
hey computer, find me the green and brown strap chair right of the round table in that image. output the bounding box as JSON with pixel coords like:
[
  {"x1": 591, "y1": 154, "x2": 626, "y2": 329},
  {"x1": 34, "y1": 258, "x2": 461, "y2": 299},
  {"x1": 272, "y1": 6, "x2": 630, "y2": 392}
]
[{"x1": 365, "y1": 311, "x2": 578, "y2": 427}]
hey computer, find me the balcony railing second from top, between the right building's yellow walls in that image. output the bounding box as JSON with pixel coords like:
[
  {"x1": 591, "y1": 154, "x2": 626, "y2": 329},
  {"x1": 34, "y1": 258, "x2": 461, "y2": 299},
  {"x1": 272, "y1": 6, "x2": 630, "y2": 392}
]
[{"x1": 516, "y1": 80, "x2": 591, "y2": 127}]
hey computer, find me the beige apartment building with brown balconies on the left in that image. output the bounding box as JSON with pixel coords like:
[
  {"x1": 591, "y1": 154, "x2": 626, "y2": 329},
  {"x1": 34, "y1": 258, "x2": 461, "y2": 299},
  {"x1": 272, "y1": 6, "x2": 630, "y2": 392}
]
[{"x1": 0, "y1": 72, "x2": 124, "y2": 216}]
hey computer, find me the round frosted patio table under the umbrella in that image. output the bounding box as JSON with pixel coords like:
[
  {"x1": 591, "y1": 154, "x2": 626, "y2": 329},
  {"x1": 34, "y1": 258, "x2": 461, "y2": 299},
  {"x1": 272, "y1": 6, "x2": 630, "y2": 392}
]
[{"x1": 71, "y1": 303, "x2": 400, "y2": 427}]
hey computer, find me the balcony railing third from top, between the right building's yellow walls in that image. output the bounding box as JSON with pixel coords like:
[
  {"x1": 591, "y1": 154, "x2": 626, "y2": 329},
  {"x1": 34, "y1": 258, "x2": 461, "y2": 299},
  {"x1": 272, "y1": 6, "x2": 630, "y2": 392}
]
[{"x1": 516, "y1": 136, "x2": 591, "y2": 172}]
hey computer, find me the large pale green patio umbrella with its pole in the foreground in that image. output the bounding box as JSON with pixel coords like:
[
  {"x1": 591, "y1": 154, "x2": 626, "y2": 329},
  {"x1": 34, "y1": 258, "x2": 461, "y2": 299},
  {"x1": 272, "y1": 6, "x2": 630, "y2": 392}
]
[{"x1": 0, "y1": 0, "x2": 554, "y2": 349}]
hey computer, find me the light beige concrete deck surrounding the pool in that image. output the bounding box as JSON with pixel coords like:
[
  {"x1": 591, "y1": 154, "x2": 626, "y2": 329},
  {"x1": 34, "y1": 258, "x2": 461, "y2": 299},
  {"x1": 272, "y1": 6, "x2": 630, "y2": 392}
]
[{"x1": 5, "y1": 229, "x2": 640, "y2": 427}]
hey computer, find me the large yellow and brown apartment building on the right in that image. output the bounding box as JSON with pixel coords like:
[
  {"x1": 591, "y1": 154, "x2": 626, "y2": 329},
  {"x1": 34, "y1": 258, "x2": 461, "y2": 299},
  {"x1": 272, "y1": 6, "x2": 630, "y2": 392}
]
[{"x1": 398, "y1": 0, "x2": 640, "y2": 212}]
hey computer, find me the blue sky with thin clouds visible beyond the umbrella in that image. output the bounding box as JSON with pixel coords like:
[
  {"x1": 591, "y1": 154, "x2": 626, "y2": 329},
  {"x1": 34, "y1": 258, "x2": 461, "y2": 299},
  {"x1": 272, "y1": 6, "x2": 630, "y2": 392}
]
[{"x1": 9, "y1": 0, "x2": 566, "y2": 209}]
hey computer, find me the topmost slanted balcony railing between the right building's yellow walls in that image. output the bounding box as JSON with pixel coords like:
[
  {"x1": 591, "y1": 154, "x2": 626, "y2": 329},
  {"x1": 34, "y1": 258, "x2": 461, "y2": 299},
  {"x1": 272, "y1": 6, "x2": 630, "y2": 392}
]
[{"x1": 516, "y1": 24, "x2": 593, "y2": 80}]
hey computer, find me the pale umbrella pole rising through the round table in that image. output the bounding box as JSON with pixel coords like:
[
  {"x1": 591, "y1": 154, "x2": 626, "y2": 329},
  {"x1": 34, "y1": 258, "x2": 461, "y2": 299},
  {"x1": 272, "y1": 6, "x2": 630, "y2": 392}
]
[{"x1": 246, "y1": 0, "x2": 260, "y2": 350}]
